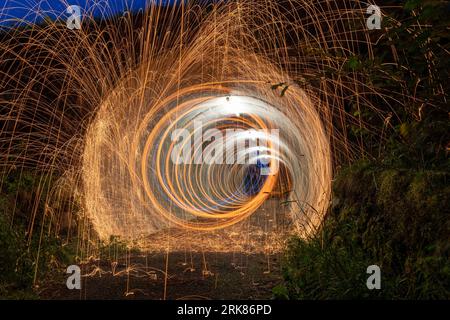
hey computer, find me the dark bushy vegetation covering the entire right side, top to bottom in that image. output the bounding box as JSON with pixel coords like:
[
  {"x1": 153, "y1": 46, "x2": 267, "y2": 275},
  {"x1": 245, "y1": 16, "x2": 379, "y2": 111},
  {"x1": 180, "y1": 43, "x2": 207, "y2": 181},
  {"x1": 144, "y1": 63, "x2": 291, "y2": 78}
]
[{"x1": 274, "y1": 0, "x2": 450, "y2": 299}]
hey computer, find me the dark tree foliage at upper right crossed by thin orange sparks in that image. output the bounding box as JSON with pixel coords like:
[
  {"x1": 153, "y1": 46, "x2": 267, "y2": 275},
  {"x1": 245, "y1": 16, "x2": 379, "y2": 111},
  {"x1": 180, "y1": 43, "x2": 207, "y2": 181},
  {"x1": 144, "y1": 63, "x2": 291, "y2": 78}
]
[{"x1": 330, "y1": 0, "x2": 450, "y2": 161}]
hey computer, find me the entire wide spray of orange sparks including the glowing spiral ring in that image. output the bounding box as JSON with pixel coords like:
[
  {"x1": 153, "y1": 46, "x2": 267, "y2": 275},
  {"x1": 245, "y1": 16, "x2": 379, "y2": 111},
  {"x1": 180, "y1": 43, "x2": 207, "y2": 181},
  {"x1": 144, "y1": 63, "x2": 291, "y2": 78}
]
[{"x1": 0, "y1": 0, "x2": 394, "y2": 255}]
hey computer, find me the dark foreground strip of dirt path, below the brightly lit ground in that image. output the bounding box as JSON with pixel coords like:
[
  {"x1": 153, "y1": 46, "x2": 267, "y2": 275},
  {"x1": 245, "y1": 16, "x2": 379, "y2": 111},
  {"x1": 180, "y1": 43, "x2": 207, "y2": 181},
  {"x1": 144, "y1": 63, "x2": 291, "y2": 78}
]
[{"x1": 39, "y1": 252, "x2": 281, "y2": 300}]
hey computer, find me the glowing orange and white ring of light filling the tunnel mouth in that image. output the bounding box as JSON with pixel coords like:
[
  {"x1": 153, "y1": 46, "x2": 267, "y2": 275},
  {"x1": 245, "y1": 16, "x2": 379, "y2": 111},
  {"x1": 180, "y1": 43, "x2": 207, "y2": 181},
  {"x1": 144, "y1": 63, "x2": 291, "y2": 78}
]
[{"x1": 85, "y1": 79, "x2": 330, "y2": 238}]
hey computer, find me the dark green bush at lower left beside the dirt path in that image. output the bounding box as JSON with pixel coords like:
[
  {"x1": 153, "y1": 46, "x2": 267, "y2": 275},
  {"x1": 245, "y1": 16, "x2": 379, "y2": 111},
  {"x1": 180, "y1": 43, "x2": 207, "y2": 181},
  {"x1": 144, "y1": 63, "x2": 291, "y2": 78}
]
[{"x1": 0, "y1": 171, "x2": 74, "y2": 299}]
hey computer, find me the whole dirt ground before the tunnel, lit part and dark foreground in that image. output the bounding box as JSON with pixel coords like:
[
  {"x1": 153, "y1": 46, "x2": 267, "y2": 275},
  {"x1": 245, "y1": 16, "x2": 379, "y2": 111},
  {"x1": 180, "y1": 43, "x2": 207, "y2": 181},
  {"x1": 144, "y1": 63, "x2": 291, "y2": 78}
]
[{"x1": 38, "y1": 199, "x2": 291, "y2": 299}]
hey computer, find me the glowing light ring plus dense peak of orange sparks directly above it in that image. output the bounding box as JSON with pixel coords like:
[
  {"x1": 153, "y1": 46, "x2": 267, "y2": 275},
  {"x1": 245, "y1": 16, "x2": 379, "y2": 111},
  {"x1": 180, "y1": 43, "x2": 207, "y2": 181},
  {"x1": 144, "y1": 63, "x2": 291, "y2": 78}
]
[{"x1": 83, "y1": 0, "x2": 331, "y2": 241}]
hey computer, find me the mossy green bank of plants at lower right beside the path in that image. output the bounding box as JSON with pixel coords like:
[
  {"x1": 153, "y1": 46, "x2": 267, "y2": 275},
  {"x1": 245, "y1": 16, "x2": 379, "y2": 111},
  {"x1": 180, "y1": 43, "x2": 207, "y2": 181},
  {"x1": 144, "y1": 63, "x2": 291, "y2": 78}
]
[{"x1": 274, "y1": 162, "x2": 450, "y2": 299}]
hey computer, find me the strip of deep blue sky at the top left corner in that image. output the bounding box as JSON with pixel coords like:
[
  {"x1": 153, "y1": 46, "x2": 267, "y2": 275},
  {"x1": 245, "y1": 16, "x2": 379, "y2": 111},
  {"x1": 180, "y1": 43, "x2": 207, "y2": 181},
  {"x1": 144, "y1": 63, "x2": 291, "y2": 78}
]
[{"x1": 0, "y1": 0, "x2": 181, "y2": 26}]
